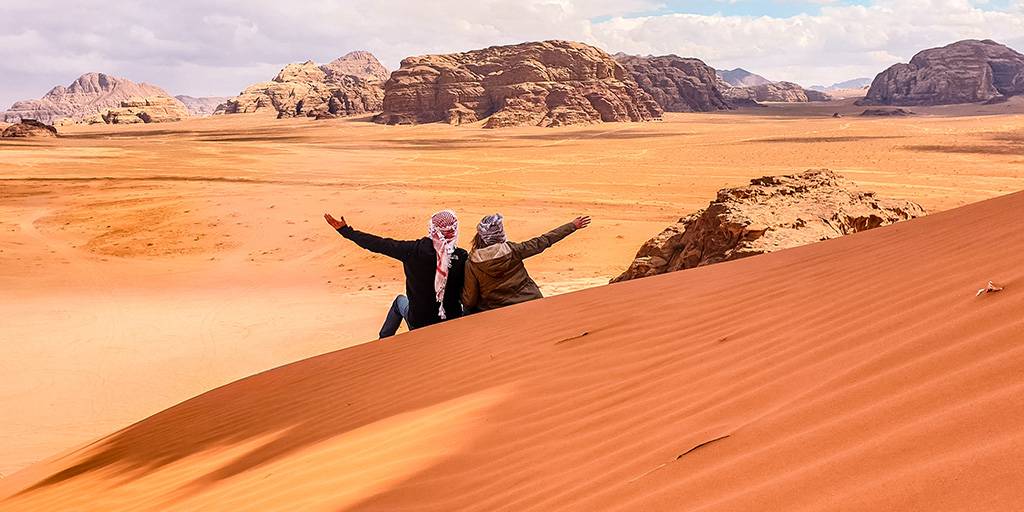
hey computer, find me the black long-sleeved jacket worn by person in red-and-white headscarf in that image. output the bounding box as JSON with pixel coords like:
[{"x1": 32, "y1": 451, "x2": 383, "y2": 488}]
[{"x1": 338, "y1": 225, "x2": 468, "y2": 329}]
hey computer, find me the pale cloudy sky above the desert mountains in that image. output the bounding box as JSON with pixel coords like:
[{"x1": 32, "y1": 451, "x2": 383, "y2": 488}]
[{"x1": 0, "y1": 0, "x2": 1024, "y2": 108}]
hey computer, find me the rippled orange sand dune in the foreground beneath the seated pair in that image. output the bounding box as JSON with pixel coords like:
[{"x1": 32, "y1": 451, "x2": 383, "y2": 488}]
[{"x1": 0, "y1": 183, "x2": 1024, "y2": 511}]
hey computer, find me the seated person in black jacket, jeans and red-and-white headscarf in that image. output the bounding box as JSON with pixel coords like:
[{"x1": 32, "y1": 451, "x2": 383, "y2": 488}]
[{"x1": 324, "y1": 210, "x2": 468, "y2": 339}]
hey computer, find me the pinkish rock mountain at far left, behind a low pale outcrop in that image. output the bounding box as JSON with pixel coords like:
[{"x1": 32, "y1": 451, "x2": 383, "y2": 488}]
[{"x1": 0, "y1": 73, "x2": 169, "y2": 124}]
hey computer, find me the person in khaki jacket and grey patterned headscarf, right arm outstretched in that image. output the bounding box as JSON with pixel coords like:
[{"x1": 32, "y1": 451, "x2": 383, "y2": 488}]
[{"x1": 462, "y1": 213, "x2": 590, "y2": 313}]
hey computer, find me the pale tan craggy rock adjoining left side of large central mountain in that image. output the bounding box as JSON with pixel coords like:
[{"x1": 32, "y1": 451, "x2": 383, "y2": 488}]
[{"x1": 216, "y1": 60, "x2": 384, "y2": 118}]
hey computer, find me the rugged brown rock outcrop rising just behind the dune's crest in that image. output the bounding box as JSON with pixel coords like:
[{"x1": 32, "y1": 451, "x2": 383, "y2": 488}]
[{"x1": 613, "y1": 170, "x2": 925, "y2": 282}]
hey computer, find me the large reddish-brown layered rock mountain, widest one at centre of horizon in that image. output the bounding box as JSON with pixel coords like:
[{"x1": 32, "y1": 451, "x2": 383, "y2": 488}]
[{"x1": 376, "y1": 41, "x2": 662, "y2": 128}]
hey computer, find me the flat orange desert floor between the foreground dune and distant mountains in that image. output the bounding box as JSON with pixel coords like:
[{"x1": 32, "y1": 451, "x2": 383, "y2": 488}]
[{"x1": 0, "y1": 102, "x2": 1024, "y2": 476}]
